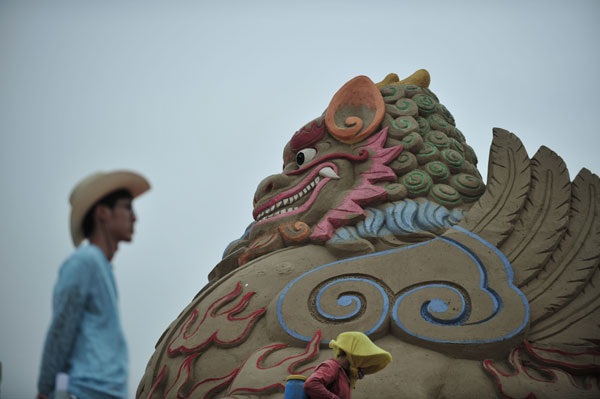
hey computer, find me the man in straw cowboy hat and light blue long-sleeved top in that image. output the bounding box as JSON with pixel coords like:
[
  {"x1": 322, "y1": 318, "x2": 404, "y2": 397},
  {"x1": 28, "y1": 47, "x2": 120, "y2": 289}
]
[{"x1": 38, "y1": 171, "x2": 150, "y2": 399}]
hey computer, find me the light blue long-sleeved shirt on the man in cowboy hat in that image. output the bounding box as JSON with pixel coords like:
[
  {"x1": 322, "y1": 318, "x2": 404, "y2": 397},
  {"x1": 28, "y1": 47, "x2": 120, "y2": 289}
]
[{"x1": 38, "y1": 245, "x2": 128, "y2": 399}]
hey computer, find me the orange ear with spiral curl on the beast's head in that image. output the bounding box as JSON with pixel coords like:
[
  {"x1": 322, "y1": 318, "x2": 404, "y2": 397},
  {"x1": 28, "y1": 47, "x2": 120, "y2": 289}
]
[{"x1": 325, "y1": 76, "x2": 385, "y2": 144}]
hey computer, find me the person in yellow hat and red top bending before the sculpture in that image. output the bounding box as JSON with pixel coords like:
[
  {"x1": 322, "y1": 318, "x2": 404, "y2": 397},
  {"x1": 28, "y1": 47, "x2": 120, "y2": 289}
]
[{"x1": 304, "y1": 331, "x2": 392, "y2": 399}]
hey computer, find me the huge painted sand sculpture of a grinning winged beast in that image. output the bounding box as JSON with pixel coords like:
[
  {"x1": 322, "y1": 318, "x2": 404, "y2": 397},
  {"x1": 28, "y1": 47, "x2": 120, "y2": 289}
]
[{"x1": 137, "y1": 70, "x2": 600, "y2": 399}]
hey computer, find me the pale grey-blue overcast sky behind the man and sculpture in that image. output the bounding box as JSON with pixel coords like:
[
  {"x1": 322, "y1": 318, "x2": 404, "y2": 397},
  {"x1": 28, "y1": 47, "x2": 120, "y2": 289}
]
[{"x1": 0, "y1": 0, "x2": 600, "y2": 398}]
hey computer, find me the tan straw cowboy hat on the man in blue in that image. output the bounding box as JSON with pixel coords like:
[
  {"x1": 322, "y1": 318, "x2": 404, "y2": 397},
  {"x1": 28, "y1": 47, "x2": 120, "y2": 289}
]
[{"x1": 69, "y1": 170, "x2": 150, "y2": 247}]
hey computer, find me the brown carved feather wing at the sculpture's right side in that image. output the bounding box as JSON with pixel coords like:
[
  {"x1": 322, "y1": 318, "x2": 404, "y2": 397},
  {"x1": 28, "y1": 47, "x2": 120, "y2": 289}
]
[{"x1": 461, "y1": 129, "x2": 600, "y2": 350}]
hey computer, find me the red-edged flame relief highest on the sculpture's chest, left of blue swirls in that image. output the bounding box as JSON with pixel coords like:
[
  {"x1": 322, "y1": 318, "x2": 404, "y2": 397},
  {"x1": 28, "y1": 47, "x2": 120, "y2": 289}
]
[{"x1": 167, "y1": 282, "x2": 267, "y2": 355}]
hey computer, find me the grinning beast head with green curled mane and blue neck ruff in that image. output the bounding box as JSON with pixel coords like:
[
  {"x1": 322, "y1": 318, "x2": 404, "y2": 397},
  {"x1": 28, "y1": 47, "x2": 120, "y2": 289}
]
[{"x1": 218, "y1": 70, "x2": 485, "y2": 272}]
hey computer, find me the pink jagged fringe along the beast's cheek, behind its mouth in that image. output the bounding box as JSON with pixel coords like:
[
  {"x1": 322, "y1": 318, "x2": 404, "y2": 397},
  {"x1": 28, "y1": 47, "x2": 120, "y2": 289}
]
[{"x1": 310, "y1": 127, "x2": 403, "y2": 242}]
